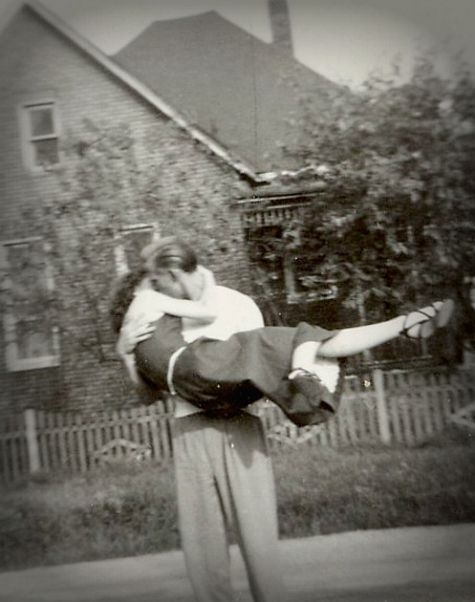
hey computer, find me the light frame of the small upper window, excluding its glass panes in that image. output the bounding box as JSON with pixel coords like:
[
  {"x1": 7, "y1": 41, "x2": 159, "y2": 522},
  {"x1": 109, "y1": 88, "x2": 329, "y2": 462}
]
[{"x1": 18, "y1": 98, "x2": 62, "y2": 174}]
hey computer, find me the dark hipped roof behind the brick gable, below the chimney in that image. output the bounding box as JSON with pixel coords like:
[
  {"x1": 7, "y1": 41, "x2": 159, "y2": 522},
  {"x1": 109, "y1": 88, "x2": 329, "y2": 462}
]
[{"x1": 114, "y1": 11, "x2": 341, "y2": 175}]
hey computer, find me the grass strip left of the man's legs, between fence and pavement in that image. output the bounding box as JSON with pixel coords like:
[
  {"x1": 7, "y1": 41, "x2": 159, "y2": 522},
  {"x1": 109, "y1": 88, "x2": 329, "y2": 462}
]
[{"x1": 0, "y1": 464, "x2": 179, "y2": 568}]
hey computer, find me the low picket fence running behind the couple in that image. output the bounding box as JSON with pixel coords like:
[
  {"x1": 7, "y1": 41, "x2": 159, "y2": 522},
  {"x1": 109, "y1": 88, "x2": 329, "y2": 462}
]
[{"x1": 0, "y1": 369, "x2": 475, "y2": 482}]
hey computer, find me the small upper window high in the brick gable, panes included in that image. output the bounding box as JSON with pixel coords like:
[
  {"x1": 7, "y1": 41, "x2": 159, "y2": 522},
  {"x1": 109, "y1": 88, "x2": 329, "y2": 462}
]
[{"x1": 21, "y1": 101, "x2": 59, "y2": 172}]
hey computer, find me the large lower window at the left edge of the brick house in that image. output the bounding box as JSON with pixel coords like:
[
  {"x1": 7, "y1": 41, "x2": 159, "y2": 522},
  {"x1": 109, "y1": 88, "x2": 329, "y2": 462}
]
[{"x1": 0, "y1": 238, "x2": 59, "y2": 372}]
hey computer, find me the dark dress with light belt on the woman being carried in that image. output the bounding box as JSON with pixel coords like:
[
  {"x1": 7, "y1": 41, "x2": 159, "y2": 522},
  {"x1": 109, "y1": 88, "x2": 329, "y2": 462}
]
[{"x1": 135, "y1": 314, "x2": 343, "y2": 426}]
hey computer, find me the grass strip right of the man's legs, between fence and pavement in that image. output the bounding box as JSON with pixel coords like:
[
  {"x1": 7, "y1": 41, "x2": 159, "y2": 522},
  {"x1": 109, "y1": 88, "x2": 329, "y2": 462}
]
[{"x1": 274, "y1": 442, "x2": 475, "y2": 537}]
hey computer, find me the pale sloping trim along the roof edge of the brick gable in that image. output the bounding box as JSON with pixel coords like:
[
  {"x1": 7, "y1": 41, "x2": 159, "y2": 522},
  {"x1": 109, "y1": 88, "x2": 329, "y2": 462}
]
[{"x1": 0, "y1": 0, "x2": 269, "y2": 183}]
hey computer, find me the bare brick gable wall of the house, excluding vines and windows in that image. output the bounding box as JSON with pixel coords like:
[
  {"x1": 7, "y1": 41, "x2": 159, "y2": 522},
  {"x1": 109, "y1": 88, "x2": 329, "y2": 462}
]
[{"x1": 0, "y1": 8, "x2": 256, "y2": 414}]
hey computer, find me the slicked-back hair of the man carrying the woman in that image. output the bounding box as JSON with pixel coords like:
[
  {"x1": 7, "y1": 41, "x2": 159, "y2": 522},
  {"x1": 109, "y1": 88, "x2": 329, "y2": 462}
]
[{"x1": 141, "y1": 236, "x2": 198, "y2": 272}]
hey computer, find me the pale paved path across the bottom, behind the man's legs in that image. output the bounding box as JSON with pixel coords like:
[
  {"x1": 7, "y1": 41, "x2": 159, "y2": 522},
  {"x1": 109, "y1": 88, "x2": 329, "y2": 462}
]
[{"x1": 0, "y1": 524, "x2": 475, "y2": 602}]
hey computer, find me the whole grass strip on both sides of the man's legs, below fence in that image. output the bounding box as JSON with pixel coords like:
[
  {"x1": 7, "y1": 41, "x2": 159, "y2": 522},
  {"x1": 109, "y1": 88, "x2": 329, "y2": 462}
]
[{"x1": 0, "y1": 426, "x2": 475, "y2": 570}]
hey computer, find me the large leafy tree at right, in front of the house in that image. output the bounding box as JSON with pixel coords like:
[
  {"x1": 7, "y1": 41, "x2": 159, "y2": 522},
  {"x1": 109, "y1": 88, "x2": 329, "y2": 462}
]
[{"x1": 256, "y1": 58, "x2": 475, "y2": 326}]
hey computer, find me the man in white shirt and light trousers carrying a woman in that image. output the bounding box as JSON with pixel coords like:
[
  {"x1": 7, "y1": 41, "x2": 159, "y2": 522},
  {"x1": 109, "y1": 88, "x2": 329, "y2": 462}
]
[{"x1": 119, "y1": 238, "x2": 285, "y2": 602}]
